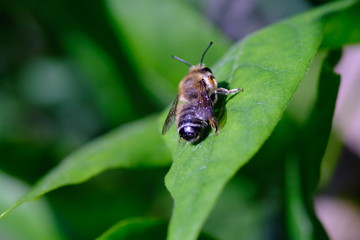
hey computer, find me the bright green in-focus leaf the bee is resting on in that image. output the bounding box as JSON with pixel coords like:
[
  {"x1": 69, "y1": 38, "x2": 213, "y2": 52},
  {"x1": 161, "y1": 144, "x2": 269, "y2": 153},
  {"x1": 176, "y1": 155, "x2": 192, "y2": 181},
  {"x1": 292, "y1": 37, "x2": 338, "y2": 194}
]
[{"x1": 166, "y1": 2, "x2": 358, "y2": 240}]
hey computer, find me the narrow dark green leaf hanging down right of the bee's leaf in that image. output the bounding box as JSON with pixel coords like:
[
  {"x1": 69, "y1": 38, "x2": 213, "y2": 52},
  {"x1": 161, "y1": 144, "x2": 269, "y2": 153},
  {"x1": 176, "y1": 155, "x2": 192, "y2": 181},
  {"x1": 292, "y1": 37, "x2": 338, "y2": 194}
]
[{"x1": 285, "y1": 51, "x2": 340, "y2": 239}]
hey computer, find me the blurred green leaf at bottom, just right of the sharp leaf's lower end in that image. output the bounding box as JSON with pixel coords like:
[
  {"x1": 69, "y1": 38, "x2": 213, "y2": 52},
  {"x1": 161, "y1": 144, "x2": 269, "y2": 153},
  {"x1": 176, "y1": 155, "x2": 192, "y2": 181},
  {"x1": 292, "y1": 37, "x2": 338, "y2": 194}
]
[{"x1": 204, "y1": 174, "x2": 270, "y2": 240}]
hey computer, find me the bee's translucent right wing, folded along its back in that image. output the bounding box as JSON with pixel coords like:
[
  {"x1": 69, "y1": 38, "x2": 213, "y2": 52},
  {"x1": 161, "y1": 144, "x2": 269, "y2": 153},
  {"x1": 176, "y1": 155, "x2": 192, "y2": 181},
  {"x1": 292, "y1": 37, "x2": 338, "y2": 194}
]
[{"x1": 197, "y1": 79, "x2": 214, "y2": 121}]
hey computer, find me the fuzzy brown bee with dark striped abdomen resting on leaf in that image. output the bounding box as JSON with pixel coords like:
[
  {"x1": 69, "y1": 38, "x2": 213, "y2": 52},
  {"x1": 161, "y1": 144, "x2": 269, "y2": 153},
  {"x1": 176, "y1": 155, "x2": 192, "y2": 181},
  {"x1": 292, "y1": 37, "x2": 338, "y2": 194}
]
[{"x1": 162, "y1": 42, "x2": 242, "y2": 143}]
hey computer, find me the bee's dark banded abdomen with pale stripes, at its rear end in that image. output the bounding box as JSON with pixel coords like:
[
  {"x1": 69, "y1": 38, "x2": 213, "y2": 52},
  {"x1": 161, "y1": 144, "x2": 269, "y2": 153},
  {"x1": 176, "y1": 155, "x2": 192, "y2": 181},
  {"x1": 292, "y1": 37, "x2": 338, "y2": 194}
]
[{"x1": 178, "y1": 107, "x2": 207, "y2": 142}]
